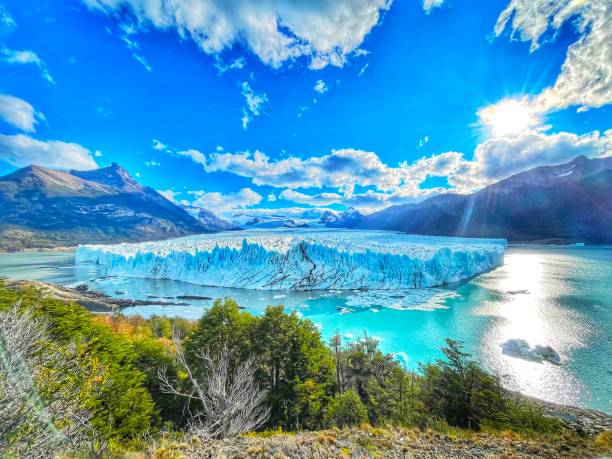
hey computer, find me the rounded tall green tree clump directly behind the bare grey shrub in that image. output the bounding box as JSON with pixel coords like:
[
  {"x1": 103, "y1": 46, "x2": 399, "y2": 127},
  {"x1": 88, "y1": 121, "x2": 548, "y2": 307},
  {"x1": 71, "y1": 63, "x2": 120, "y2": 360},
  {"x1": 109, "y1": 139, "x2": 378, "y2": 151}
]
[{"x1": 185, "y1": 299, "x2": 334, "y2": 430}]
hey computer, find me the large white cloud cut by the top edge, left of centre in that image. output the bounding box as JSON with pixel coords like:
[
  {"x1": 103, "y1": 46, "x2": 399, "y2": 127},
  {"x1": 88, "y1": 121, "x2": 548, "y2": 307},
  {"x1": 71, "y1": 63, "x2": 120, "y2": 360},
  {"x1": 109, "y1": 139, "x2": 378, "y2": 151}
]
[{"x1": 82, "y1": 0, "x2": 391, "y2": 69}]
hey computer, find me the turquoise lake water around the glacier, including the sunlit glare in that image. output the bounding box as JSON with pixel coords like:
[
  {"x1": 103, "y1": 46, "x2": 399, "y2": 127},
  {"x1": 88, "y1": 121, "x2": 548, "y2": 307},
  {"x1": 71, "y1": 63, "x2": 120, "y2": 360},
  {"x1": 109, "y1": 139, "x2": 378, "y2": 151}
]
[{"x1": 0, "y1": 247, "x2": 612, "y2": 413}]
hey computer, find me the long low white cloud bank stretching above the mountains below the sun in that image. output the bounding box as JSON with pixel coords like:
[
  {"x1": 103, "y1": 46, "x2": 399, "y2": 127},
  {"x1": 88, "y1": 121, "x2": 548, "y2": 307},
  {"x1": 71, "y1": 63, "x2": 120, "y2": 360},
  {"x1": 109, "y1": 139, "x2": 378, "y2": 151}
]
[{"x1": 155, "y1": 126, "x2": 612, "y2": 214}]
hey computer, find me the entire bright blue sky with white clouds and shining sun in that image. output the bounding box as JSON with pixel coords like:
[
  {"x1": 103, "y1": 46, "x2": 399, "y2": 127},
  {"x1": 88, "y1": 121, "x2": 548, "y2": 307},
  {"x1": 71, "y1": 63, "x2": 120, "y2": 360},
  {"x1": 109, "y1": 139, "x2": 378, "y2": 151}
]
[{"x1": 0, "y1": 0, "x2": 612, "y2": 217}]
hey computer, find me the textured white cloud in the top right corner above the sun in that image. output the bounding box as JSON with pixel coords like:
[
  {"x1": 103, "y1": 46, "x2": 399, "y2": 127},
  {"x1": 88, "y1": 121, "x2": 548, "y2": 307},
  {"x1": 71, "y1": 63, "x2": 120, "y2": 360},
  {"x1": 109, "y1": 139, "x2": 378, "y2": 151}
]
[{"x1": 495, "y1": 0, "x2": 612, "y2": 113}]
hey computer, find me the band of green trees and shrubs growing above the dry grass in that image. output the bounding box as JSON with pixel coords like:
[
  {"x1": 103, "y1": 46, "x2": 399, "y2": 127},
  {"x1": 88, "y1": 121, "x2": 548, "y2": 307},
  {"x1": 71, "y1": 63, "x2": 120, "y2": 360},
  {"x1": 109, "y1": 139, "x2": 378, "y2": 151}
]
[{"x1": 0, "y1": 280, "x2": 584, "y2": 456}]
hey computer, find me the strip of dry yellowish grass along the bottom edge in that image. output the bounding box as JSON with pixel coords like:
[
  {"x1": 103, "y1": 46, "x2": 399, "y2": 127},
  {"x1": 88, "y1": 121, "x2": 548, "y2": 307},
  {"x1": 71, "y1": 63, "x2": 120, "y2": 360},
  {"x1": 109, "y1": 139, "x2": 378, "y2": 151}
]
[{"x1": 163, "y1": 425, "x2": 610, "y2": 459}]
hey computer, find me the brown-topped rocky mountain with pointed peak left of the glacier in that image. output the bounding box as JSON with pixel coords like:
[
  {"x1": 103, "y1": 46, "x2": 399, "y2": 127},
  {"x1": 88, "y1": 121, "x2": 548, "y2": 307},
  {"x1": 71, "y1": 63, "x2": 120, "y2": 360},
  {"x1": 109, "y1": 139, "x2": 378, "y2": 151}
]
[{"x1": 0, "y1": 163, "x2": 221, "y2": 250}]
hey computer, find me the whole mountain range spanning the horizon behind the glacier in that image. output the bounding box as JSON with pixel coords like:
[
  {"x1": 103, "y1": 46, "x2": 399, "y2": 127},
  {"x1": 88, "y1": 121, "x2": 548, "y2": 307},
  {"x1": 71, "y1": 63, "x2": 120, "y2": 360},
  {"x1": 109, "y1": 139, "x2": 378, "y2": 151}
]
[{"x1": 0, "y1": 156, "x2": 612, "y2": 250}]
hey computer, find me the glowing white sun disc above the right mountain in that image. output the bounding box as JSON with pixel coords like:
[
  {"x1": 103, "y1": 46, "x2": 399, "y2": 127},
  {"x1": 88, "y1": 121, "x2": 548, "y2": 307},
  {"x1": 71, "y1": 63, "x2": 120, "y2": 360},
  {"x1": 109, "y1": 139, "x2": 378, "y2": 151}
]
[{"x1": 478, "y1": 99, "x2": 539, "y2": 137}]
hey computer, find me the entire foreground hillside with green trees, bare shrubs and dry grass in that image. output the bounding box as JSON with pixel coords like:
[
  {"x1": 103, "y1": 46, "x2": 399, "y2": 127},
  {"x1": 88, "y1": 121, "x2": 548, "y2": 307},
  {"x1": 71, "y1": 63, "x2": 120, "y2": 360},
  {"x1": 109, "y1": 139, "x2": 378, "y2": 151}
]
[{"x1": 0, "y1": 285, "x2": 610, "y2": 457}]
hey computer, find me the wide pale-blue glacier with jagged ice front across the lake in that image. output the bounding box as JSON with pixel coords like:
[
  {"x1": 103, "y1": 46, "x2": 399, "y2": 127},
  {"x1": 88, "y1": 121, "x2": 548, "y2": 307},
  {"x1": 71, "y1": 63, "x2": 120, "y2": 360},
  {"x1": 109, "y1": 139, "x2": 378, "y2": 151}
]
[{"x1": 76, "y1": 229, "x2": 506, "y2": 291}]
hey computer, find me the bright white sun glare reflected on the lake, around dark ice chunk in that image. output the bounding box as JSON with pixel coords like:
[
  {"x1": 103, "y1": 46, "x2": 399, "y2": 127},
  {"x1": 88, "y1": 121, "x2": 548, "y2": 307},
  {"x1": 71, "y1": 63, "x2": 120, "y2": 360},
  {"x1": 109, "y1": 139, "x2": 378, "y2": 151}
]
[{"x1": 474, "y1": 253, "x2": 590, "y2": 404}]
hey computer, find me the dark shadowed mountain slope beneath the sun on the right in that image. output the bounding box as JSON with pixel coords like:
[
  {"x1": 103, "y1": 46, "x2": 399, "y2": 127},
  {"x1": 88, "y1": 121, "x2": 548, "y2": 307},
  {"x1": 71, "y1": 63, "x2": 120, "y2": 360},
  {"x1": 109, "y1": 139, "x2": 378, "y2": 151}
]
[{"x1": 349, "y1": 156, "x2": 612, "y2": 244}]
